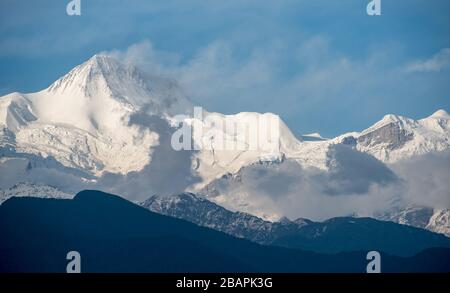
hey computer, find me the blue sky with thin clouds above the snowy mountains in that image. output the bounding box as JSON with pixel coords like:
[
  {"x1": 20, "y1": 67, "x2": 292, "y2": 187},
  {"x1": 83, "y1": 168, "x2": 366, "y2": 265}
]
[{"x1": 0, "y1": 0, "x2": 450, "y2": 136}]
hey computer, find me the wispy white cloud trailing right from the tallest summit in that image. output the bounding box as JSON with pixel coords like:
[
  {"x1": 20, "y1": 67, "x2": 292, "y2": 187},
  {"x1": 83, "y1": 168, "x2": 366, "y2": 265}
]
[{"x1": 109, "y1": 40, "x2": 276, "y2": 112}]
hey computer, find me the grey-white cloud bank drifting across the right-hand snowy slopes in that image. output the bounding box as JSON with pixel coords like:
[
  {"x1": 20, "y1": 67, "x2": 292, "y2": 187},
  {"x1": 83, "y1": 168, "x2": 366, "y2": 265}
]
[{"x1": 204, "y1": 146, "x2": 450, "y2": 221}]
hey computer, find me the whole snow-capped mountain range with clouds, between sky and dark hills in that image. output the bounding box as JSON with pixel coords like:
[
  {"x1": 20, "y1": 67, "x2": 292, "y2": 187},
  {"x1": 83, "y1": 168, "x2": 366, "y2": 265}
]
[{"x1": 0, "y1": 54, "x2": 450, "y2": 239}]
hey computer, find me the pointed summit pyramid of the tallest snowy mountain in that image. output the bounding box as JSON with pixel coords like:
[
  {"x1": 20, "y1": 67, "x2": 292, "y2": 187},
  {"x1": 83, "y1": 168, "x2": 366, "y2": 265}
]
[{"x1": 45, "y1": 53, "x2": 191, "y2": 114}]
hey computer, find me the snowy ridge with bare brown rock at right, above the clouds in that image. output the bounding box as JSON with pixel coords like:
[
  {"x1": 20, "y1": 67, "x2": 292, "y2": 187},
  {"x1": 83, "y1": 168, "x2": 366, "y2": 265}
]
[{"x1": 286, "y1": 109, "x2": 450, "y2": 170}]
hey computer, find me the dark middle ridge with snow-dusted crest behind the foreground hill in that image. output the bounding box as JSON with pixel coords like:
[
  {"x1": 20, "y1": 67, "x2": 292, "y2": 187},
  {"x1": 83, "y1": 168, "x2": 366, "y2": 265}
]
[{"x1": 140, "y1": 193, "x2": 450, "y2": 256}]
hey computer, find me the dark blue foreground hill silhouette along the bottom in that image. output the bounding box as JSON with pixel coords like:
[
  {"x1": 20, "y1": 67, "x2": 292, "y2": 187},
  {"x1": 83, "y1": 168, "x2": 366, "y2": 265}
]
[{"x1": 0, "y1": 191, "x2": 450, "y2": 272}]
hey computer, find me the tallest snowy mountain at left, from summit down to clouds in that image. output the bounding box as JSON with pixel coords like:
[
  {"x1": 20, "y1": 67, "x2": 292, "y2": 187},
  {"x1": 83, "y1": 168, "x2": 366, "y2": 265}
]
[{"x1": 0, "y1": 55, "x2": 190, "y2": 176}]
